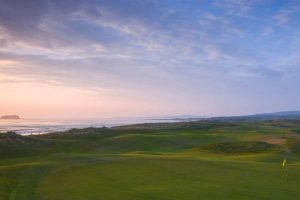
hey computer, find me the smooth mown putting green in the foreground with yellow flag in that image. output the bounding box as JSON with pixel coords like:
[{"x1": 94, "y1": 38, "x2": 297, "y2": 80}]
[{"x1": 38, "y1": 158, "x2": 300, "y2": 200}]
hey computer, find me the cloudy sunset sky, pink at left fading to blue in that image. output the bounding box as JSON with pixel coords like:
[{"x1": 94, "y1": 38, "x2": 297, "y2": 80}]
[{"x1": 0, "y1": 0, "x2": 300, "y2": 118}]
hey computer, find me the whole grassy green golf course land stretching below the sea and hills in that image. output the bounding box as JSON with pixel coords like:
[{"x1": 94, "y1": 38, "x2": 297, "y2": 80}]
[{"x1": 0, "y1": 120, "x2": 300, "y2": 200}]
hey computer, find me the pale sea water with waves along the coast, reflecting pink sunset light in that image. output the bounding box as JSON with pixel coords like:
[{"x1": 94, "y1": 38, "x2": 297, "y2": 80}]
[{"x1": 0, "y1": 118, "x2": 186, "y2": 135}]
